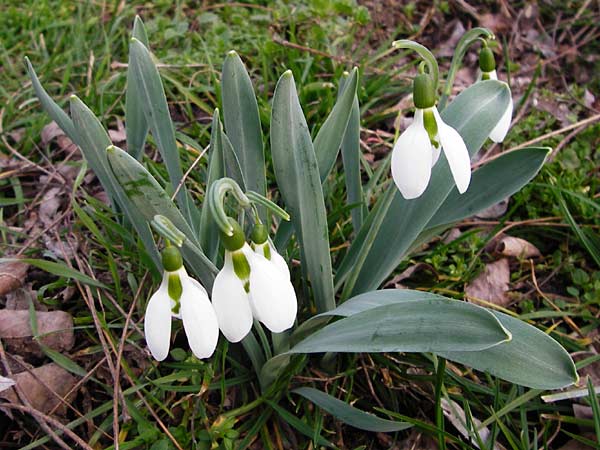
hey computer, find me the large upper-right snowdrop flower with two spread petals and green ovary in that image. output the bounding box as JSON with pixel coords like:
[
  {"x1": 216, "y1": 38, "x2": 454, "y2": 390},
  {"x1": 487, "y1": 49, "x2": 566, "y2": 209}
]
[{"x1": 392, "y1": 73, "x2": 471, "y2": 199}]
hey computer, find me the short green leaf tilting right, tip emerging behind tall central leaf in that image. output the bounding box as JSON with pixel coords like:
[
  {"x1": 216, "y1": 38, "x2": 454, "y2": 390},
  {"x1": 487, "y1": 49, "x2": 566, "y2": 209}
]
[{"x1": 313, "y1": 68, "x2": 358, "y2": 182}]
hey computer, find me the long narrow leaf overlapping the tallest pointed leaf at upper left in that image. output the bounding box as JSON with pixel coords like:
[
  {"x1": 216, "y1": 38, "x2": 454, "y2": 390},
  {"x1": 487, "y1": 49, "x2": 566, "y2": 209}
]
[{"x1": 129, "y1": 38, "x2": 200, "y2": 227}]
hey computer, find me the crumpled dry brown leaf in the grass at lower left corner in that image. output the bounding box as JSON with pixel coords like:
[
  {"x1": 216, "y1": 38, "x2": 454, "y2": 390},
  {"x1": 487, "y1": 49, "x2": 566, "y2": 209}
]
[{"x1": 0, "y1": 363, "x2": 77, "y2": 415}]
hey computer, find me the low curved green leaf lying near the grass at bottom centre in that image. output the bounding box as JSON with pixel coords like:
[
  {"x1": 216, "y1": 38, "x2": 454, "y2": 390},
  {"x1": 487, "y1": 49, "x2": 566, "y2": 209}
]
[{"x1": 292, "y1": 387, "x2": 412, "y2": 433}]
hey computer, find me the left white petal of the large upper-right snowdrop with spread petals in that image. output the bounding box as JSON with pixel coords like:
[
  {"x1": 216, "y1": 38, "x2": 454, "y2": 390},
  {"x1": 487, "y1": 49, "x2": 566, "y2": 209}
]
[{"x1": 392, "y1": 109, "x2": 433, "y2": 199}]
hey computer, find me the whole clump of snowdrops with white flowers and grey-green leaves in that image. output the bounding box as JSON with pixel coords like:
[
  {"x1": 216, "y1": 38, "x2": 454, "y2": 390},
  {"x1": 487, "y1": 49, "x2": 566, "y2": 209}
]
[{"x1": 27, "y1": 18, "x2": 578, "y2": 431}]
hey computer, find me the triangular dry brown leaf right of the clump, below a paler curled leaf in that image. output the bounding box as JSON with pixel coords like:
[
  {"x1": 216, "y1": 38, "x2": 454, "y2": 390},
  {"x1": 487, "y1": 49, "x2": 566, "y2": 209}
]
[{"x1": 465, "y1": 258, "x2": 510, "y2": 306}]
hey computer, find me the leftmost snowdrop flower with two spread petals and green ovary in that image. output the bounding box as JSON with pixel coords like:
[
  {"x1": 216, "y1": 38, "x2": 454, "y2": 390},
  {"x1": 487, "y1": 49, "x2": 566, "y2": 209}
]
[{"x1": 144, "y1": 247, "x2": 219, "y2": 361}]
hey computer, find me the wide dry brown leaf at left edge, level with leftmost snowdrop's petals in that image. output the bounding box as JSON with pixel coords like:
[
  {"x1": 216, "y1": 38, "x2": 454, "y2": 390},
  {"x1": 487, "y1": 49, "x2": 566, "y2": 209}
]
[{"x1": 0, "y1": 309, "x2": 75, "y2": 355}]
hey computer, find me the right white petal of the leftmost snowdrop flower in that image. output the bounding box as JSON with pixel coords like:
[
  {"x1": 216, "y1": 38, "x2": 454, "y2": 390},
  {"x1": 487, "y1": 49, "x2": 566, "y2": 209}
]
[{"x1": 181, "y1": 278, "x2": 219, "y2": 358}]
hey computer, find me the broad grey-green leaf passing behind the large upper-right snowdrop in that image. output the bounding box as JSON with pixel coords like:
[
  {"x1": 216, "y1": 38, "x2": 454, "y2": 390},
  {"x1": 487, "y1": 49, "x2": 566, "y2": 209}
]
[{"x1": 342, "y1": 80, "x2": 510, "y2": 297}]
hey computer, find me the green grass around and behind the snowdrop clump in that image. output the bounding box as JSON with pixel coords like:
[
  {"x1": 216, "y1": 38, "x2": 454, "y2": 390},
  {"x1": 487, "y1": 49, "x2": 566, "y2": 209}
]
[{"x1": 0, "y1": 0, "x2": 600, "y2": 450}]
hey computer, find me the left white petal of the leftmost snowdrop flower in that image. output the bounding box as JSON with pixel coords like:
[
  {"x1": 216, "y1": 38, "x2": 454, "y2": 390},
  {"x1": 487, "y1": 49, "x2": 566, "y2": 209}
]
[{"x1": 144, "y1": 280, "x2": 171, "y2": 361}]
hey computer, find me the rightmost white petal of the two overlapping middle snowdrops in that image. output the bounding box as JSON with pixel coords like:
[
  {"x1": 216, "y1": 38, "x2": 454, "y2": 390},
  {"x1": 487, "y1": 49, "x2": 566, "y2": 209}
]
[{"x1": 250, "y1": 255, "x2": 298, "y2": 333}]
